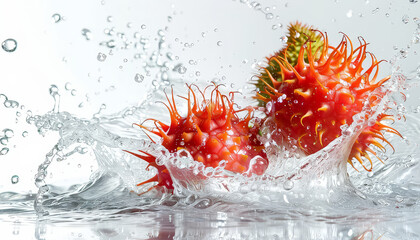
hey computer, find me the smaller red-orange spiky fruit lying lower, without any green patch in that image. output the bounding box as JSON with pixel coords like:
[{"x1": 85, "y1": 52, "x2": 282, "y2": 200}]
[{"x1": 129, "y1": 86, "x2": 268, "y2": 192}]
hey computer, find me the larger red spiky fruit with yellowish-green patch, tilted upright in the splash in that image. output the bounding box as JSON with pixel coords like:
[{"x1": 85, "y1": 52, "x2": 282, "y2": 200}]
[{"x1": 257, "y1": 25, "x2": 401, "y2": 171}]
